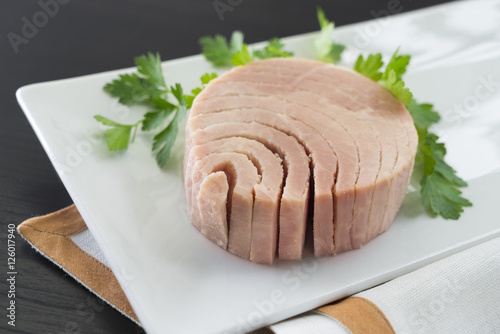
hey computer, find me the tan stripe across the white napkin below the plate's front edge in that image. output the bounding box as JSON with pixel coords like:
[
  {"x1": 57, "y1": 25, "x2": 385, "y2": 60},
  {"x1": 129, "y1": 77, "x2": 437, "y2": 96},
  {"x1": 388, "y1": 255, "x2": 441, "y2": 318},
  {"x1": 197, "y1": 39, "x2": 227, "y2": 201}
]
[{"x1": 317, "y1": 297, "x2": 396, "y2": 334}]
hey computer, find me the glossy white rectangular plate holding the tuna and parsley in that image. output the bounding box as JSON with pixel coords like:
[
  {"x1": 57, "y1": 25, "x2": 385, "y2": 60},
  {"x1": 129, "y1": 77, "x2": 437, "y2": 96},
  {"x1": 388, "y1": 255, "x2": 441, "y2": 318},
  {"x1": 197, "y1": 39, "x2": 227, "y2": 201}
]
[{"x1": 17, "y1": 1, "x2": 500, "y2": 333}]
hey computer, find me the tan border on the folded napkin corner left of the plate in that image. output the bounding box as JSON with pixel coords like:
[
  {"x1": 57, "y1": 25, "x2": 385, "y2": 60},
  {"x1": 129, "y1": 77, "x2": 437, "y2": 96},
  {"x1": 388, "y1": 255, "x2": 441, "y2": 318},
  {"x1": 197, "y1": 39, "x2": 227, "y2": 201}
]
[{"x1": 17, "y1": 205, "x2": 139, "y2": 321}]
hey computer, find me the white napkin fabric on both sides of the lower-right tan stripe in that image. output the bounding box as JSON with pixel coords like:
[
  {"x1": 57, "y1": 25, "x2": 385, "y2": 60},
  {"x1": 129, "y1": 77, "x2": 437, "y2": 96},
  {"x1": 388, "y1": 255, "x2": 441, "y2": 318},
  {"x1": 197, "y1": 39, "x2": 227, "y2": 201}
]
[{"x1": 270, "y1": 238, "x2": 500, "y2": 334}]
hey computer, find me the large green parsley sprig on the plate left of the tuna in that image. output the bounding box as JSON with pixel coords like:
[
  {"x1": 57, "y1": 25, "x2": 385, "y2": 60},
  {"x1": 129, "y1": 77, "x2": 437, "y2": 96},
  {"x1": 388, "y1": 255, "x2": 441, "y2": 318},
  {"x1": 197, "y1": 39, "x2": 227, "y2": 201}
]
[{"x1": 94, "y1": 53, "x2": 217, "y2": 167}]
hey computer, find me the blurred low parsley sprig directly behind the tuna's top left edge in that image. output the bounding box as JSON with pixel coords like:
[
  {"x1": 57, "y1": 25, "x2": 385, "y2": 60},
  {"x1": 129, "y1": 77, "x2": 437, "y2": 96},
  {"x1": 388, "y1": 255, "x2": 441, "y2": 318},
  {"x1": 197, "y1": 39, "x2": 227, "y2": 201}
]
[{"x1": 199, "y1": 31, "x2": 293, "y2": 67}]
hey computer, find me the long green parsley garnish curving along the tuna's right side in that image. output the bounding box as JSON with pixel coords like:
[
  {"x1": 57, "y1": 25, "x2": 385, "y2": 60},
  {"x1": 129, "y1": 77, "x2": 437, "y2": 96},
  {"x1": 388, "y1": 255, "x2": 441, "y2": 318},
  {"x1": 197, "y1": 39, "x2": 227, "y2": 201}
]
[{"x1": 354, "y1": 50, "x2": 472, "y2": 219}]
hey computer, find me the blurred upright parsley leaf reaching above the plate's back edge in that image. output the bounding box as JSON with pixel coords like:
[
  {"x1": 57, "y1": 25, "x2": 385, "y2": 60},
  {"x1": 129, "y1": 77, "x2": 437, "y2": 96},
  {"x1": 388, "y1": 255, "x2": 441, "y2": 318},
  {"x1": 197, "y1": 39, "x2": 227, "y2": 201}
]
[{"x1": 314, "y1": 7, "x2": 345, "y2": 63}]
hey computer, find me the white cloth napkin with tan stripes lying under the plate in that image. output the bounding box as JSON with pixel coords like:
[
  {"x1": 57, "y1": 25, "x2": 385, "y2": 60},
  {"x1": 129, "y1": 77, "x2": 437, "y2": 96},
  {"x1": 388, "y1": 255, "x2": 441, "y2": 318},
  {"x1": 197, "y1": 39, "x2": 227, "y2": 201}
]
[{"x1": 18, "y1": 205, "x2": 500, "y2": 334}]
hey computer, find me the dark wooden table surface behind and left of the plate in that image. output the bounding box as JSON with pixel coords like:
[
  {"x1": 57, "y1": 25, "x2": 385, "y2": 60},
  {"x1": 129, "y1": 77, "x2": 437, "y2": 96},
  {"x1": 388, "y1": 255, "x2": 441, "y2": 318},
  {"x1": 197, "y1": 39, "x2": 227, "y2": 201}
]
[{"x1": 0, "y1": 0, "x2": 452, "y2": 334}]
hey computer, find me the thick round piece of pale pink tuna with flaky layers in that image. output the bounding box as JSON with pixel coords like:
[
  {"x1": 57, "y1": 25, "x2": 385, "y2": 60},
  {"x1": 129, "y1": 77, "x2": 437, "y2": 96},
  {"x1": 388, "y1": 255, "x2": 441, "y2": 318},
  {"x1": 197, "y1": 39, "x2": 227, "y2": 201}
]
[{"x1": 184, "y1": 58, "x2": 417, "y2": 263}]
